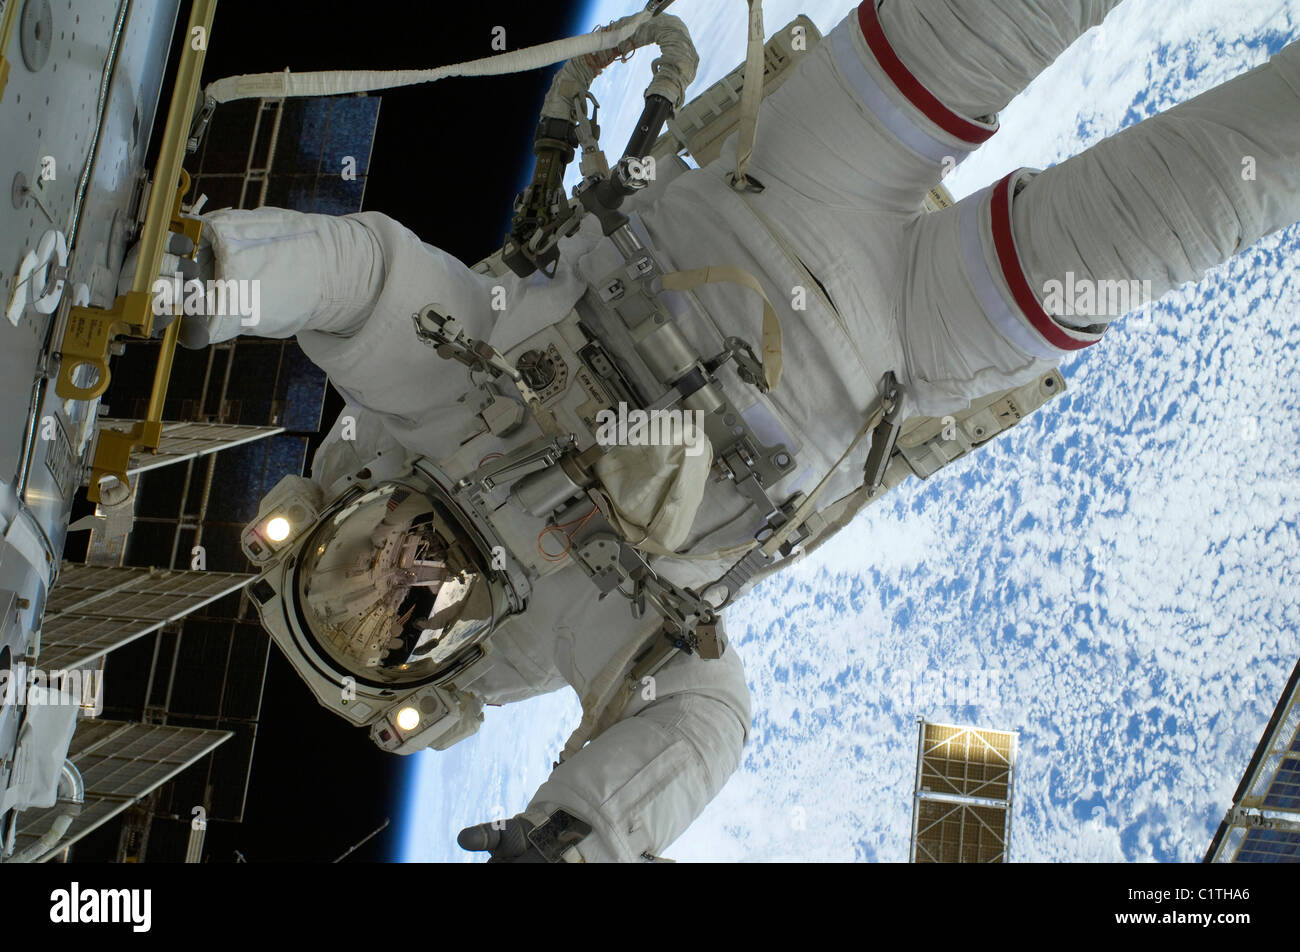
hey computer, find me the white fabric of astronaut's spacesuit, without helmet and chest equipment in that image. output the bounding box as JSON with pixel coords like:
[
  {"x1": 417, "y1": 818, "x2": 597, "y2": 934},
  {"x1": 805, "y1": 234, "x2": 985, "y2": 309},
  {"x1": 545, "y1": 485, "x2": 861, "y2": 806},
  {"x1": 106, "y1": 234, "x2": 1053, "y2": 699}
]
[{"x1": 188, "y1": 0, "x2": 1300, "y2": 861}]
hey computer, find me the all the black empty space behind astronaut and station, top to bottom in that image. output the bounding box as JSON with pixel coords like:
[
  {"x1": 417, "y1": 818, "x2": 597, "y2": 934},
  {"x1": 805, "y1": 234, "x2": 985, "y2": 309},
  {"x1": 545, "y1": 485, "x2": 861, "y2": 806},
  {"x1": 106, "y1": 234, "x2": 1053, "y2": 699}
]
[{"x1": 68, "y1": 0, "x2": 584, "y2": 862}]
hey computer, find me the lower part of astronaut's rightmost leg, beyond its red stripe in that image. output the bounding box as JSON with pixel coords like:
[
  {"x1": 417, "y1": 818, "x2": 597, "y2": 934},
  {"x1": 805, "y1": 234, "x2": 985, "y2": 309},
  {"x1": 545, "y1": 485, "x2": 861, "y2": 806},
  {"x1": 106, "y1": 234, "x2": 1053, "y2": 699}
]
[{"x1": 1011, "y1": 43, "x2": 1300, "y2": 328}]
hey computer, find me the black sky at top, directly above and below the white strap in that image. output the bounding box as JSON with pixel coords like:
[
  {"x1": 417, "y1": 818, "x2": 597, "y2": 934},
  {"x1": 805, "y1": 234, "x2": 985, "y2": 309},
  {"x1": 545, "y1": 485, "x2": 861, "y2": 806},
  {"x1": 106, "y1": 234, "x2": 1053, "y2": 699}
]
[{"x1": 203, "y1": 0, "x2": 585, "y2": 249}]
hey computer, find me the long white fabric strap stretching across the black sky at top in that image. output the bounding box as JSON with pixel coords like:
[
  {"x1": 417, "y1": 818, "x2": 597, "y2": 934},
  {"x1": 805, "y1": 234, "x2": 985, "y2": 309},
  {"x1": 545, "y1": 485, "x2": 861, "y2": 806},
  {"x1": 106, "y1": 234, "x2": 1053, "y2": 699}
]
[{"x1": 204, "y1": 10, "x2": 651, "y2": 103}]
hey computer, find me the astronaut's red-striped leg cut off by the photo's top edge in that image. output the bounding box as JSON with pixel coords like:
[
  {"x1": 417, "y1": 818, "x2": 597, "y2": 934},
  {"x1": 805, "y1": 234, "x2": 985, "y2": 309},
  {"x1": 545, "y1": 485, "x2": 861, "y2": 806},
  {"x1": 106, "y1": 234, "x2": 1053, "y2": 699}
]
[{"x1": 743, "y1": 0, "x2": 1119, "y2": 215}]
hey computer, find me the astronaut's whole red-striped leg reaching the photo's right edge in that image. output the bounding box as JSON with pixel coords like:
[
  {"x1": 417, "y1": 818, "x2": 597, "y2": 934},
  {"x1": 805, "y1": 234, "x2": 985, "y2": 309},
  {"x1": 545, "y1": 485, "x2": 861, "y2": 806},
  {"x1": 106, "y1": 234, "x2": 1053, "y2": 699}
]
[{"x1": 900, "y1": 44, "x2": 1300, "y2": 415}]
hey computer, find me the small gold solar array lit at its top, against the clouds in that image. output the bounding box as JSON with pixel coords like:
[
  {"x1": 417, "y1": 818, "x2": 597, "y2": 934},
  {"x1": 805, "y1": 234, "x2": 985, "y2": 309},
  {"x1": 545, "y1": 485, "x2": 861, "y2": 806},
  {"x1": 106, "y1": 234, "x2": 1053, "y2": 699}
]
[{"x1": 911, "y1": 721, "x2": 1015, "y2": 862}]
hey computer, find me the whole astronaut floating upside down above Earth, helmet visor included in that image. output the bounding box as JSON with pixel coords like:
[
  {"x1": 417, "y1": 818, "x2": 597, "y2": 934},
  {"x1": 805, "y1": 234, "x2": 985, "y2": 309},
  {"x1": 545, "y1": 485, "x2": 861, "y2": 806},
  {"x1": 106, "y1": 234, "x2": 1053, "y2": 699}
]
[{"x1": 178, "y1": 0, "x2": 1300, "y2": 861}]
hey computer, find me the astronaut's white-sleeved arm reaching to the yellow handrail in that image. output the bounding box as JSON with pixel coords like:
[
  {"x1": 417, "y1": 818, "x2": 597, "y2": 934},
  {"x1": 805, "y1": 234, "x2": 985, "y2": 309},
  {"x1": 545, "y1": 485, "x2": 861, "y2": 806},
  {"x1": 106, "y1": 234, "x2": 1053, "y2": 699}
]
[{"x1": 195, "y1": 208, "x2": 508, "y2": 420}]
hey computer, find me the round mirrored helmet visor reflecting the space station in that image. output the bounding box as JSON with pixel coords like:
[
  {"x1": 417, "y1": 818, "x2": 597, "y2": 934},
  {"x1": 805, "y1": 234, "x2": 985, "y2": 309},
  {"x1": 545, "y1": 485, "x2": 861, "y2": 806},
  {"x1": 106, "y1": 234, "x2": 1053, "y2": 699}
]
[{"x1": 298, "y1": 485, "x2": 491, "y2": 683}]
